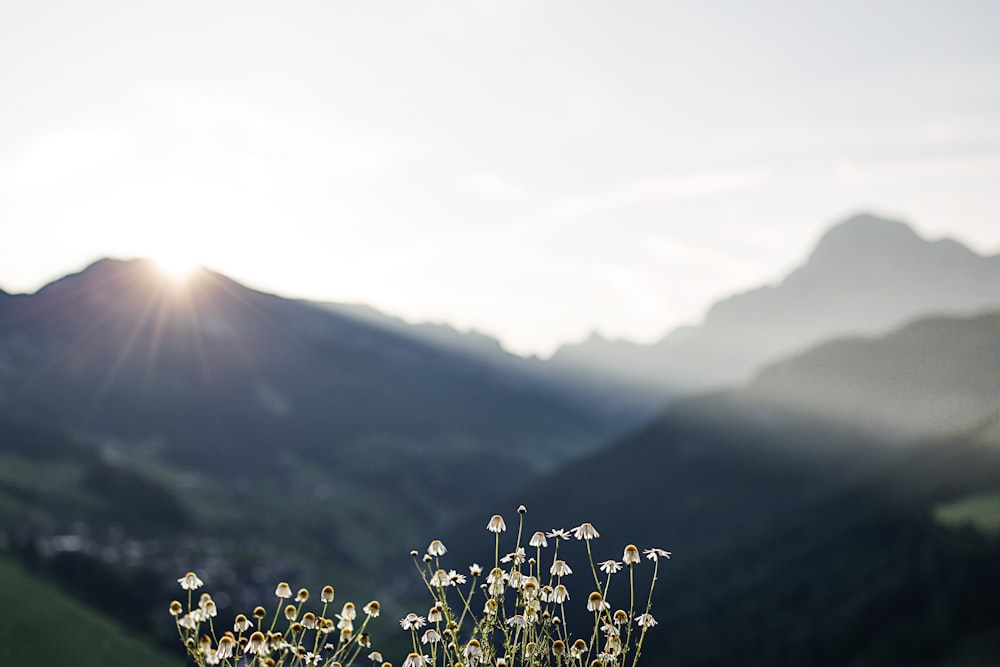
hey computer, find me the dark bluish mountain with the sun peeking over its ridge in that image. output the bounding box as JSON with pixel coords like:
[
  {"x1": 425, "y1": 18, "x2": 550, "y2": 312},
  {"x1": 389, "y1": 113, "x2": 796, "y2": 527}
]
[{"x1": 0, "y1": 260, "x2": 617, "y2": 567}]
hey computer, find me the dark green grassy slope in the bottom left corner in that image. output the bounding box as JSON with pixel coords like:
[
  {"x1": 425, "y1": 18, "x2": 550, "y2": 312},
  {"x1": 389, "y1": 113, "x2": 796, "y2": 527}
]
[{"x1": 0, "y1": 558, "x2": 184, "y2": 667}]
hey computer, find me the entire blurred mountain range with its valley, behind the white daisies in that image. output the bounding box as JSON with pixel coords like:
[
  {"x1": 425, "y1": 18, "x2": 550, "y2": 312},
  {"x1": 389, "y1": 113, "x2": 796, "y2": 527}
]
[{"x1": 0, "y1": 216, "x2": 1000, "y2": 667}]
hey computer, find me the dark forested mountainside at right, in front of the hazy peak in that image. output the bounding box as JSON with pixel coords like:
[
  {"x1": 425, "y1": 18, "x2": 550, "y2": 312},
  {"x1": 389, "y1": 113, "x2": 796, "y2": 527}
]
[{"x1": 434, "y1": 314, "x2": 1000, "y2": 667}]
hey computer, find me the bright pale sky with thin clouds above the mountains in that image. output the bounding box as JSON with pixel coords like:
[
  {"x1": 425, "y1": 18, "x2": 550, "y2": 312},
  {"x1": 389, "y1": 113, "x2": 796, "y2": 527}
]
[{"x1": 0, "y1": 0, "x2": 1000, "y2": 356}]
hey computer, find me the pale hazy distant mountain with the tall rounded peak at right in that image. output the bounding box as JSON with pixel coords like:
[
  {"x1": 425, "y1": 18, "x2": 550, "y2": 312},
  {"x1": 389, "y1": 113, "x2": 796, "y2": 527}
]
[{"x1": 551, "y1": 215, "x2": 1000, "y2": 403}]
